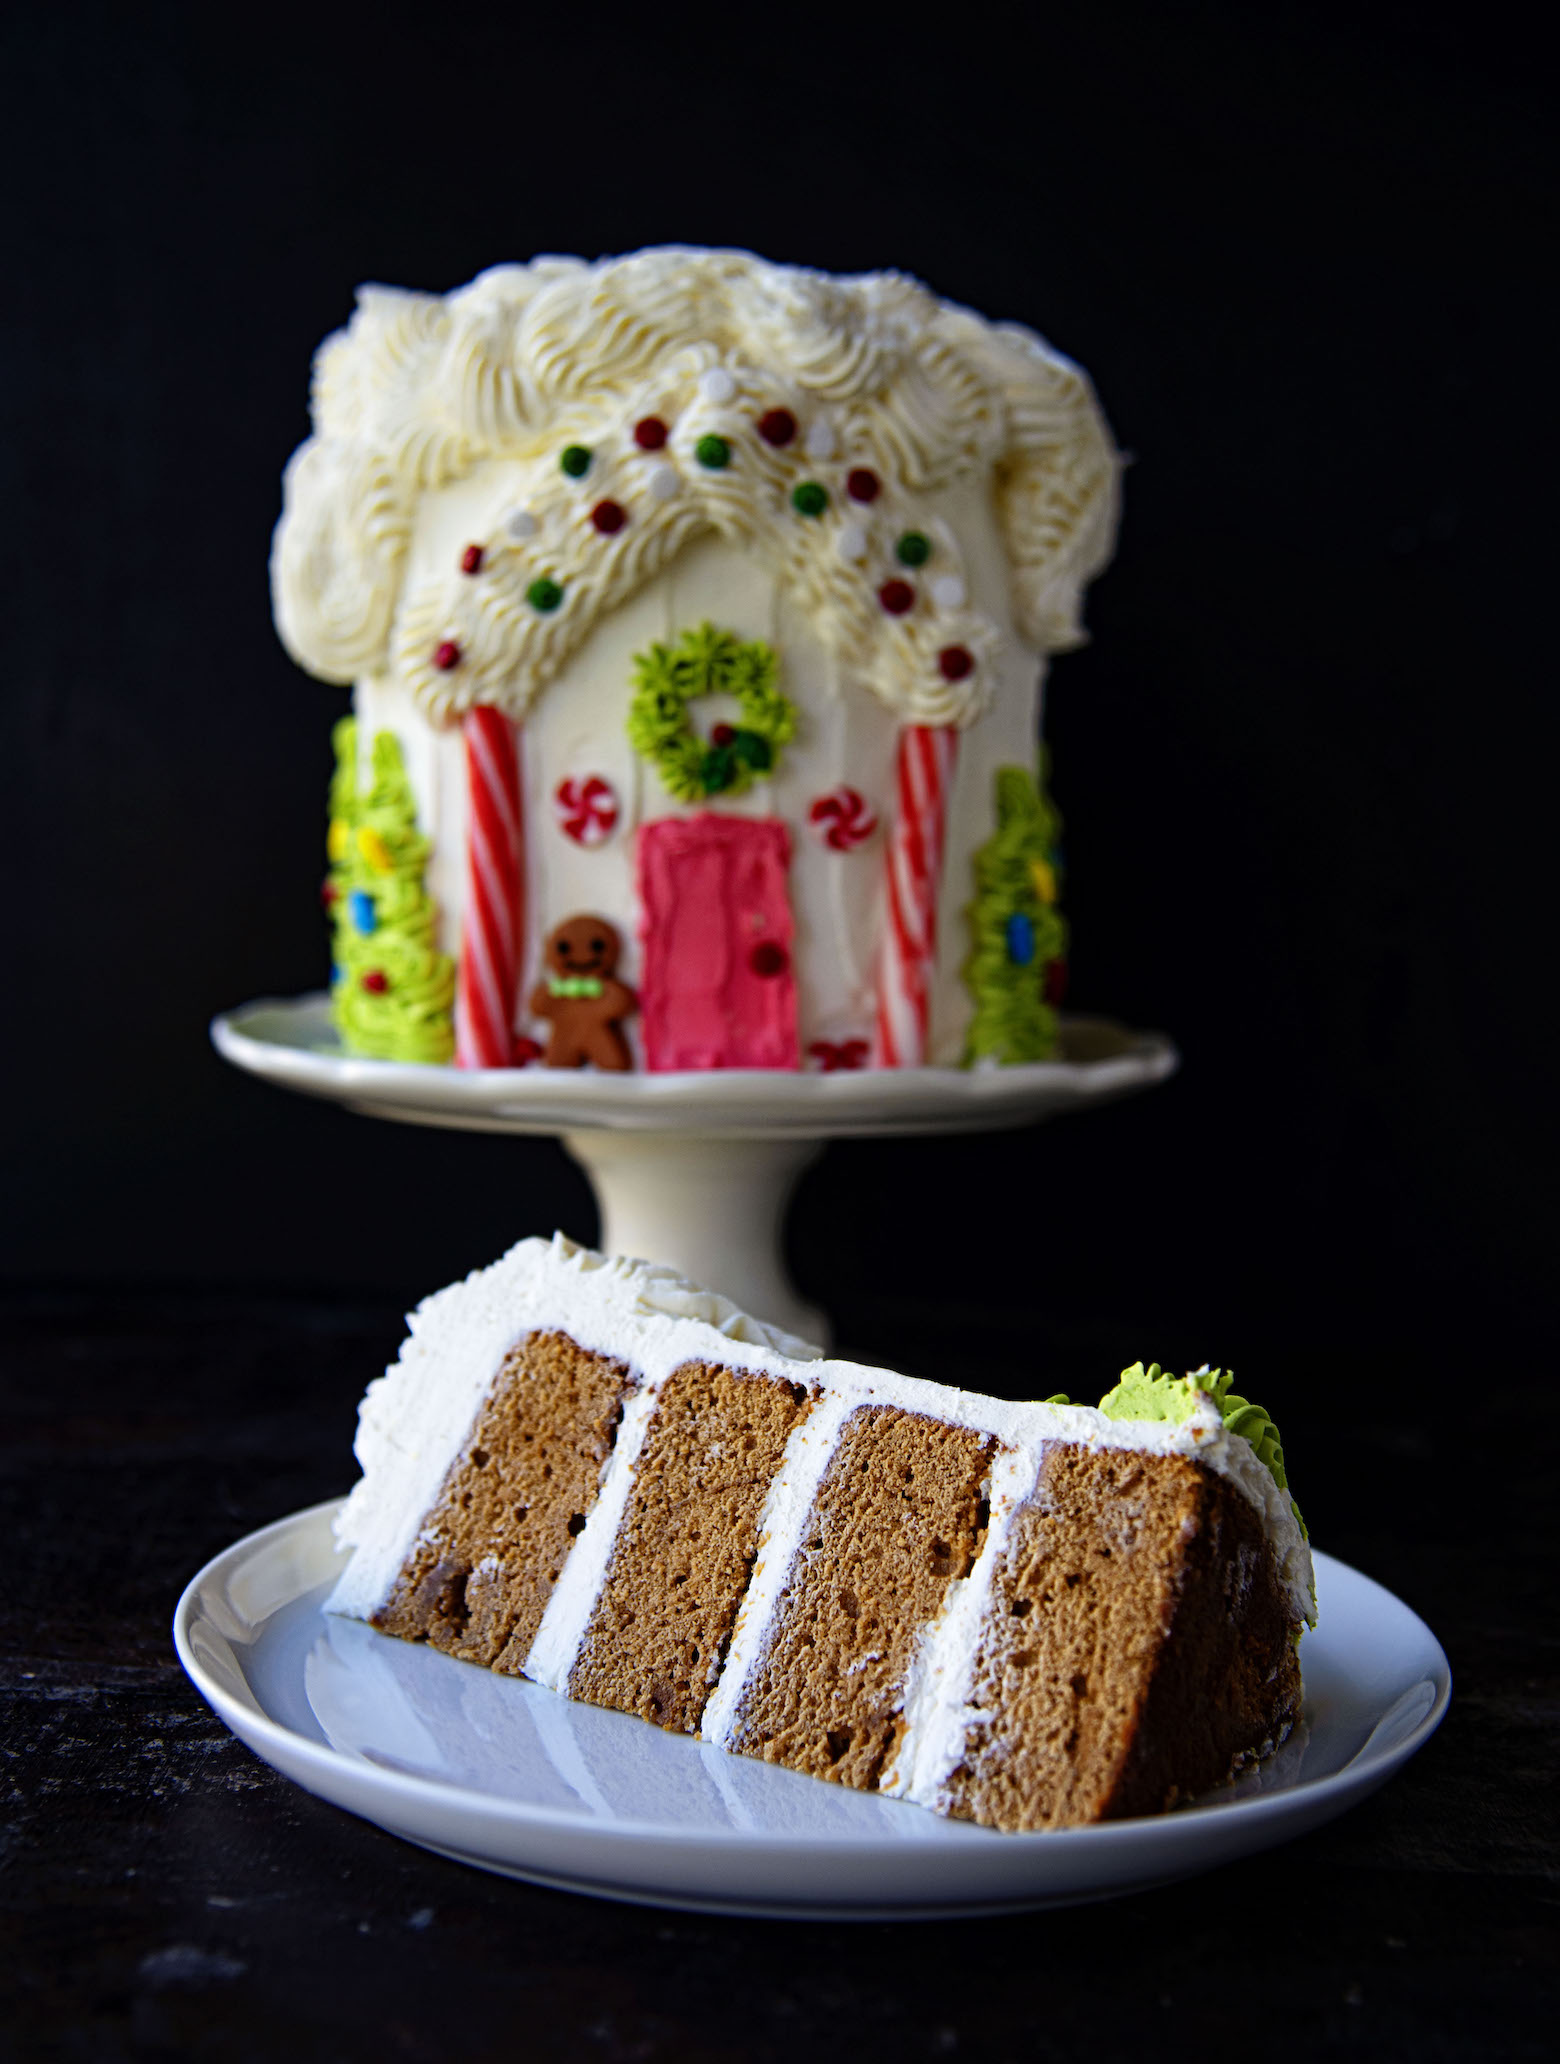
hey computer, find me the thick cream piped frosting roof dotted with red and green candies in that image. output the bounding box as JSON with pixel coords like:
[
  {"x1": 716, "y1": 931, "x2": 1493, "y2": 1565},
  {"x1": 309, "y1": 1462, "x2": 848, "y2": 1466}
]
[{"x1": 272, "y1": 248, "x2": 1118, "y2": 724}]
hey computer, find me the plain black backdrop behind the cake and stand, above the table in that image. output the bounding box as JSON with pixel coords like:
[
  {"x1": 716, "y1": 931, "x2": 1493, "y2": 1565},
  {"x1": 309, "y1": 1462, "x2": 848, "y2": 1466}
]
[{"x1": 0, "y1": 6, "x2": 1556, "y2": 1381}]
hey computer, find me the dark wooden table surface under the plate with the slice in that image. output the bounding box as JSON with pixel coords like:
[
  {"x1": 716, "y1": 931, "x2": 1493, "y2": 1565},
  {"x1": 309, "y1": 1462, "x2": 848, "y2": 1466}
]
[{"x1": 0, "y1": 1296, "x2": 1560, "y2": 2064}]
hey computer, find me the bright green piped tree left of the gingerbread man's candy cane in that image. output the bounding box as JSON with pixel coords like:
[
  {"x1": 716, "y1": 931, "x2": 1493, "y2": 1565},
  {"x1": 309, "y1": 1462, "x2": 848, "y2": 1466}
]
[{"x1": 326, "y1": 716, "x2": 456, "y2": 1061}]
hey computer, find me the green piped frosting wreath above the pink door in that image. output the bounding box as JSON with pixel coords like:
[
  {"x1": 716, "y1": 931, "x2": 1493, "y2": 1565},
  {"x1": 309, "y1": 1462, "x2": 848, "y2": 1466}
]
[{"x1": 627, "y1": 623, "x2": 797, "y2": 803}]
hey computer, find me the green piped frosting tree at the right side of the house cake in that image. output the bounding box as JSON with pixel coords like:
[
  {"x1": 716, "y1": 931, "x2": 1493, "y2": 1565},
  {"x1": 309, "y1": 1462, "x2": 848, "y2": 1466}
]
[{"x1": 964, "y1": 757, "x2": 1067, "y2": 1067}]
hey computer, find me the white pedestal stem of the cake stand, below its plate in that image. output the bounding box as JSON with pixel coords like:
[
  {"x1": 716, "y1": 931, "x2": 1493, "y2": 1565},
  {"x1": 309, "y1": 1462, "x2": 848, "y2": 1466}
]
[{"x1": 563, "y1": 1129, "x2": 830, "y2": 1344}]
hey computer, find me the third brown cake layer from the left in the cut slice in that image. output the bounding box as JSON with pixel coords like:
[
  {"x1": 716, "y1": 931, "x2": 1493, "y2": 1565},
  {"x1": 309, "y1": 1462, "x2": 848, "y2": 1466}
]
[{"x1": 730, "y1": 1406, "x2": 995, "y2": 1792}]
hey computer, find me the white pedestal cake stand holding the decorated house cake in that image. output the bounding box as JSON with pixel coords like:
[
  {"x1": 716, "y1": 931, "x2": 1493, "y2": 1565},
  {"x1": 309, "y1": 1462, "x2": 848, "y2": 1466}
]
[{"x1": 210, "y1": 995, "x2": 1178, "y2": 1342}]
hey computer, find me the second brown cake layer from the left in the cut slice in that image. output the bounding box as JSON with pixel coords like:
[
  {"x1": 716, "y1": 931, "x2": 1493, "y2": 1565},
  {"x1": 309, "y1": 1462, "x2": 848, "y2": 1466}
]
[{"x1": 570, "y1": 1362, "x2": 811, "y2": 1734}]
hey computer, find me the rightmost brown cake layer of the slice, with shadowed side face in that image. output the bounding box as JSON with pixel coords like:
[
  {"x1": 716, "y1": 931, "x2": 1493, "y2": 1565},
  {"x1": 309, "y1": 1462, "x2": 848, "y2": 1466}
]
[{"x1": 949, "y1": 1445, "x2": 1300, "y2": 1829}]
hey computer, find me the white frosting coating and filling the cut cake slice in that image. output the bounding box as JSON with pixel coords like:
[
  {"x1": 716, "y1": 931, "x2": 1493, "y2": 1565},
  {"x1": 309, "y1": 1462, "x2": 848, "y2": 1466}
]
[{"x1": 328, "y1": 1234, "x2": 1314, "y2": 1806}]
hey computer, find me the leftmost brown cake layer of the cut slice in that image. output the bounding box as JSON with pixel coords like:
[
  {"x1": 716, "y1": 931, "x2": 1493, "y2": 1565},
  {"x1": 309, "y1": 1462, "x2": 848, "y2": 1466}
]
[{"x1": 373, "y1": 1333, "x2": 633, "y2": 1676}]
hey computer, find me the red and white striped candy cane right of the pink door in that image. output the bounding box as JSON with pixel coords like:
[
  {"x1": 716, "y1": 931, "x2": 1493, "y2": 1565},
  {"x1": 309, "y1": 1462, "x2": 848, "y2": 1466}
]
[{"x1": 873, "y1": 724, "x2": 960, "y2": 1067}]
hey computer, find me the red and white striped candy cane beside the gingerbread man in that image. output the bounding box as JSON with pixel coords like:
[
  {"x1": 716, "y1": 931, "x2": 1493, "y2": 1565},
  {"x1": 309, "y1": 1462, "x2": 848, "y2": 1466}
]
[{"x1": 456, "y1": 706, "x2": 526, "y2": 1067}]
